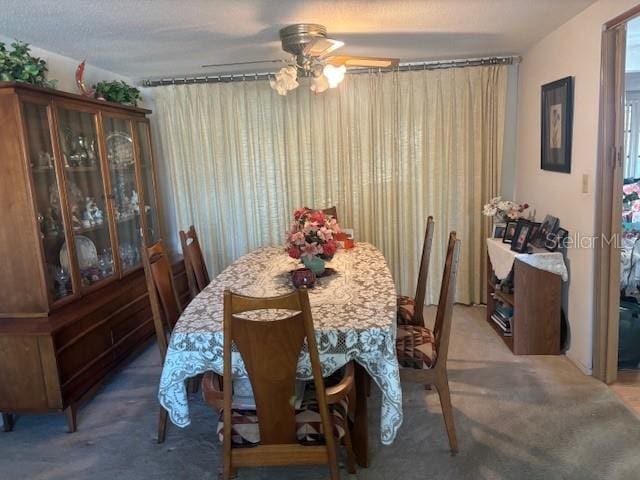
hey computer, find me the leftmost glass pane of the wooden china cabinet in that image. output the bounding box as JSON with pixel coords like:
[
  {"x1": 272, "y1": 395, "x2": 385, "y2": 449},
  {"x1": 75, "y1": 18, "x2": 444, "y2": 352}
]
[{"x1": 22, "y1": 101, "x2": 74, "y2": 302}]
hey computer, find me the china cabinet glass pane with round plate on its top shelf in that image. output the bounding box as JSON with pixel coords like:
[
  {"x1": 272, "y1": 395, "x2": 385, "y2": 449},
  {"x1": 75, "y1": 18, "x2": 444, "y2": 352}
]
[{"x1": 103, "y1": 116, "x2": 142, "y2": 272}]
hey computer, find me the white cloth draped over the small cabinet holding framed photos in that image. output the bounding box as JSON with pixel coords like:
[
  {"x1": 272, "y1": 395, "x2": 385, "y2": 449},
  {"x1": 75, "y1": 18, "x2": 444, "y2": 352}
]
[{"x1": 487, "y1": 238, "x2": 569, "y2": 282}]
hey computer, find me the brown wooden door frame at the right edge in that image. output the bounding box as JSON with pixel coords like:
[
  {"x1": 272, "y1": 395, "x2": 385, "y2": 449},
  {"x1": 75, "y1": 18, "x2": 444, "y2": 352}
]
[{"x1": 593, "y1": 5, "x2": 640, "y2": 383}]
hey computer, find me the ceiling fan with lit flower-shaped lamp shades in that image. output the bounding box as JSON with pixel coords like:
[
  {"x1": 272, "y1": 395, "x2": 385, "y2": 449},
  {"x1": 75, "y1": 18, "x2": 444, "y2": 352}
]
[{"x1": 202, "y1": 23, "x2": 399, "y2": 95}]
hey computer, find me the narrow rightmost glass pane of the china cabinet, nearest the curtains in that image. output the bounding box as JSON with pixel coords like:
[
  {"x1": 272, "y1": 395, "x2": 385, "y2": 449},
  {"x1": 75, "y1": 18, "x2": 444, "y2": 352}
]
[{"x1": 136, "y1": 122, "x2": 160, "y2": 245}]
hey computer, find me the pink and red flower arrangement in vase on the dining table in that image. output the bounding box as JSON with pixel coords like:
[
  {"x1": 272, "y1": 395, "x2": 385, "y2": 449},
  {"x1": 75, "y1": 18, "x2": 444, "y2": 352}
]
[{"x1": 287, "y1": 207, "x2": 341, "y2": 275}]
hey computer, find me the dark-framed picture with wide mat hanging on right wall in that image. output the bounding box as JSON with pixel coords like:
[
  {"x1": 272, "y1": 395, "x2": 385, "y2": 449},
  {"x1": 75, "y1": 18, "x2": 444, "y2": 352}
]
[{"x1": 540, "y1": 77, "x2": 573, "y2": 173}]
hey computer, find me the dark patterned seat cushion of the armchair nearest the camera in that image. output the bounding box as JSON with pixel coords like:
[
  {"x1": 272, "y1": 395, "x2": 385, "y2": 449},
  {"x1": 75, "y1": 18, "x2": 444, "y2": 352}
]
[{"x1": 218, "y1": 394, "x2": 349, "y2": 447}]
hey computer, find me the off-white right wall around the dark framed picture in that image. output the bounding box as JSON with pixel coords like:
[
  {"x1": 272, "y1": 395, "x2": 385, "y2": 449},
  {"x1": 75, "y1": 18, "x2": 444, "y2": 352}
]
[{"x1": 516, "y1": 0, "x2": 638, "y2": 373}]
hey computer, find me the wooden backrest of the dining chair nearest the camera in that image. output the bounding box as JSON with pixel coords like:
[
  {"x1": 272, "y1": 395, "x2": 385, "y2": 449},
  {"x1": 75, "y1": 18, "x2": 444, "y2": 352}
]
[{"x1": 223, "y1": 289, "x2": 333, "y2": 445}]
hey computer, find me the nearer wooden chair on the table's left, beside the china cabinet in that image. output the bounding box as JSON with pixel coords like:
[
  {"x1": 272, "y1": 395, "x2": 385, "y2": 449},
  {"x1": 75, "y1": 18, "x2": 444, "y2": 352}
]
[{"x1": 141, "y1": 242, "x2": 182, "y2": 443}]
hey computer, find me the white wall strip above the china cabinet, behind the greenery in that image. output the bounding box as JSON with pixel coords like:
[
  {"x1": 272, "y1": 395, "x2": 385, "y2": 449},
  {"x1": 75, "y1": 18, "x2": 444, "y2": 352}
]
[{"x1": 0, "y1": 35, "x2": 133, "y2": 93}]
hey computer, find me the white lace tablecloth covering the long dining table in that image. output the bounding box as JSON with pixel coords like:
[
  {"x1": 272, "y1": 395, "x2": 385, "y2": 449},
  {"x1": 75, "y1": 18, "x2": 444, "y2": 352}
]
[{"x1": 158, "y1": 243, "x2": 402, "y2": 444}]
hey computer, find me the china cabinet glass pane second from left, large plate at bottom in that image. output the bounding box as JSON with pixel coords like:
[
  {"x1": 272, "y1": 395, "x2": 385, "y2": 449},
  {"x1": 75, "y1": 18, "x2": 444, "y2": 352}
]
[{"x1": 57, "y1": 107, "x2": 115, "y2": 287}]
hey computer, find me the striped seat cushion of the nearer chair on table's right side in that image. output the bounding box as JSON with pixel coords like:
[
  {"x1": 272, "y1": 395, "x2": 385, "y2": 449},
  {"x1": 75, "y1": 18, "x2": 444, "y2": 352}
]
[{"x1": 396, "y1": 325, "x2": 436, "y2": 368}]
